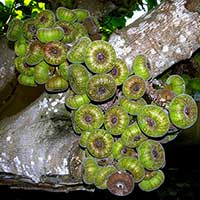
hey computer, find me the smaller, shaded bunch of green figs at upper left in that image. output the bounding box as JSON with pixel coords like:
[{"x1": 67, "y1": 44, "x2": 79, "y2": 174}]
[{"x1": 7, "y1": 7, "x2": 100, "y2": 92}]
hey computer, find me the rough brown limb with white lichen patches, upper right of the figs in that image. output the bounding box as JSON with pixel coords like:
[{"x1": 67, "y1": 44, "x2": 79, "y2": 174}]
[{"x1": 110, "y1": 0, "x2": 200, "y2": 77}]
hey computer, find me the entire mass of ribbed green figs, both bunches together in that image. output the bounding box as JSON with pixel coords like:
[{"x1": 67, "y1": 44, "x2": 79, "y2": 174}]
[{"x1": 7, "y1": 7, "x2": 198, "y2": 196}]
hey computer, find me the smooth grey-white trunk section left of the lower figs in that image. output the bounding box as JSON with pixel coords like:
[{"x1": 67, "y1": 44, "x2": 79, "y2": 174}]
[{"x1": 0, "y1": 94, "x2": 90, "y2": 191}]
